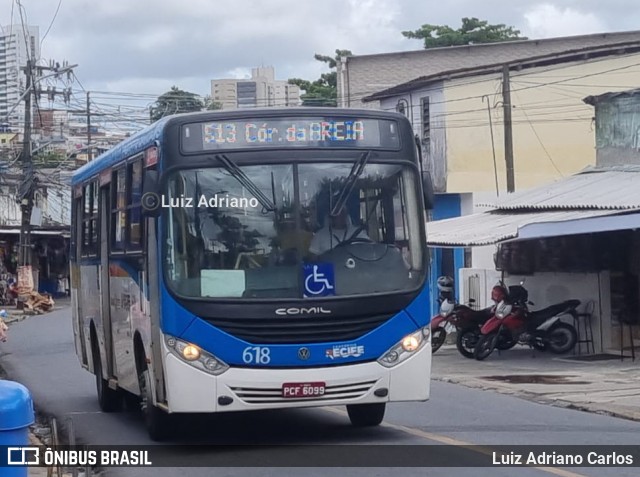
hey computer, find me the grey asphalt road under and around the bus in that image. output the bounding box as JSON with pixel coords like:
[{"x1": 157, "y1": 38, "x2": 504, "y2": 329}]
[{"x1": 0, "y1": 309, "x2": 640, "y2": 477}]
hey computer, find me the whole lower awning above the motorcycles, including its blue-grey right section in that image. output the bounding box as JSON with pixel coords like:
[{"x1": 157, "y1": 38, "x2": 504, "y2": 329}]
[{"x1": 427, "y1": 209, "x2": 640, "y2": 247}]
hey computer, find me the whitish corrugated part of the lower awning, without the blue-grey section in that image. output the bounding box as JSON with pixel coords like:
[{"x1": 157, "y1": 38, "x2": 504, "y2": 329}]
[{"x1": 427, "y1": 207, "x2": 640, "y2": 247}]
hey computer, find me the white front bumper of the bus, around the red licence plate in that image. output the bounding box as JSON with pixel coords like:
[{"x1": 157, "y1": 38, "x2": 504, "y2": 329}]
[{"x1": 164, "y1": 342, "x2": 431, "y2": 413}]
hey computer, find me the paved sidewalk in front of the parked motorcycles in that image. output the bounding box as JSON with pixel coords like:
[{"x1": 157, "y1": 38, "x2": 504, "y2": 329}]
[{"x1": 432, "y1": 345, "x2": 640, "y2": 421}]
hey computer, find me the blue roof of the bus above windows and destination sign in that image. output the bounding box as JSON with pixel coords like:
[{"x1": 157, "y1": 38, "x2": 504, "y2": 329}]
[{"x1": 71, "y1": 107, "x2": 406, "y2": 186}]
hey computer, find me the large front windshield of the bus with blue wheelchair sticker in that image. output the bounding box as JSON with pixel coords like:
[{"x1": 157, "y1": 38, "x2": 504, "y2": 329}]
[{"x1": 162, "y1": 162, "x2": 425, "y2": 299}]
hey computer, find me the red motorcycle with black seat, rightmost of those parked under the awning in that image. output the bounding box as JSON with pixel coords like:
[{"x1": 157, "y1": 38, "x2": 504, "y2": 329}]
[{"x1": 473, "y1": 282, "x2": 580, "y2": 360}]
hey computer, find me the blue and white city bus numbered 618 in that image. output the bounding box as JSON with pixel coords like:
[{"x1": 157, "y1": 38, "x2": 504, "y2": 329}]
[{"x1": 71, "y1": 108, "x2": 431, "y2": 440}]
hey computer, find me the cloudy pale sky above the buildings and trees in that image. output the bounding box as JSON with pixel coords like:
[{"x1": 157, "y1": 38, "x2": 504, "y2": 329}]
[{"x1": 0, "y1": 0, "x2": 640, "y2": 122}]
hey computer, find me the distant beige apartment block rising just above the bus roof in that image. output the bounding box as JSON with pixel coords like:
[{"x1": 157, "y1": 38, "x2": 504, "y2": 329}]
[{"x1": 211, "y1": 66, "x2": 300, "y2": 109}]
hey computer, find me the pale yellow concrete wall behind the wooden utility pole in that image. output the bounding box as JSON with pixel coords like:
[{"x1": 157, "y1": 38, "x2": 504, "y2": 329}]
[{"x1": 444, "y1": 54, "x2": 640, "y2": 192}]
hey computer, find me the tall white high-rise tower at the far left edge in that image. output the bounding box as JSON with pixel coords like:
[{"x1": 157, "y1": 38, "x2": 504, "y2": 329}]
[{"x1": 0, "y1": 25, "x2": 40, "y2": 132}]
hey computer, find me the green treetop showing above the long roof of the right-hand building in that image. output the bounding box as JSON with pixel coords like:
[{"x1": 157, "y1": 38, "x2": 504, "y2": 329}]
[{"x1": 402, "y1": 17, "x2": 527, "y2": 49}]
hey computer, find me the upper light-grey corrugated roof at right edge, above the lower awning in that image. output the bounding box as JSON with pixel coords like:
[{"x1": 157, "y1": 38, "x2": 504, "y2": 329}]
[{"x1": 482, "y1": 165, "x2": 640, "y2": 210}]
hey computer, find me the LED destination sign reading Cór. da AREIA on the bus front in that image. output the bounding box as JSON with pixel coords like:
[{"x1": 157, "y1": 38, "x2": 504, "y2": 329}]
[{"x1": 182, "y1": 118, "x2": 399, "y2": 152}]
